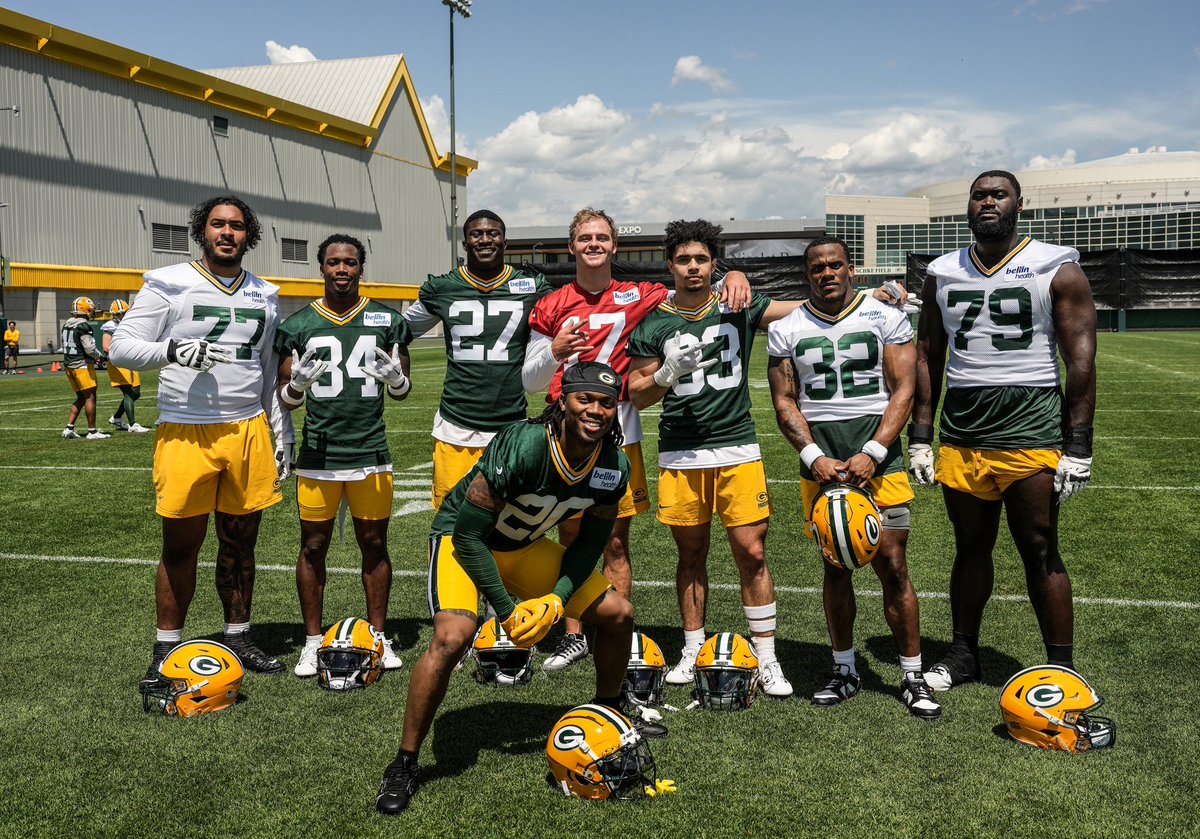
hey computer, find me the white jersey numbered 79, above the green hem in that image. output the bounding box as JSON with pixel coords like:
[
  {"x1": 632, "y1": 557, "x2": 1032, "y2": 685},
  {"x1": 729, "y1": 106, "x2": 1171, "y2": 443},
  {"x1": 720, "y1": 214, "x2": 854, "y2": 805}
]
[{"x1": 926, "y1": 236, "x2": 1079, "y2": 388}]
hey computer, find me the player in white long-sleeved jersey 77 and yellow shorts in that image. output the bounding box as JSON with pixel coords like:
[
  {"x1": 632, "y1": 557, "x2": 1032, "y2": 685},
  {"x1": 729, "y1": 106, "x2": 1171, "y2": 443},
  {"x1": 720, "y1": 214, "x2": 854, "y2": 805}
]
[{"x1": 109, "y1": 196, "x2": 293, "y2": 679}]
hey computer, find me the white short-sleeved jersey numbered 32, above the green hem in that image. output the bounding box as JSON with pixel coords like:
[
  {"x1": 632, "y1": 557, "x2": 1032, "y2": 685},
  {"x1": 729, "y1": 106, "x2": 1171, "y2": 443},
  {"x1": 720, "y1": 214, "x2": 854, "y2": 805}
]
[{"x1": 767, "y1": 293, "x2": 912, "y2": 423}]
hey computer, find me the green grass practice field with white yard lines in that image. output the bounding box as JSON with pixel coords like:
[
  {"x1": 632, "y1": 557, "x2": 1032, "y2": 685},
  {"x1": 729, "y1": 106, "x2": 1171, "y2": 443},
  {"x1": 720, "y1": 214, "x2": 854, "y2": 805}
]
[{"x1": 0, "y1": 332, "x2": 1200, "y2": 837}]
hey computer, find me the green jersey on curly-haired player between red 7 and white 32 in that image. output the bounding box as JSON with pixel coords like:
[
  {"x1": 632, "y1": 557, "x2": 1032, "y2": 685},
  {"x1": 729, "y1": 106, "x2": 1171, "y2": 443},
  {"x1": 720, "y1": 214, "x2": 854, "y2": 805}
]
[{"x1": 629, "y1": 294, "x2": 770, "y2": 451}]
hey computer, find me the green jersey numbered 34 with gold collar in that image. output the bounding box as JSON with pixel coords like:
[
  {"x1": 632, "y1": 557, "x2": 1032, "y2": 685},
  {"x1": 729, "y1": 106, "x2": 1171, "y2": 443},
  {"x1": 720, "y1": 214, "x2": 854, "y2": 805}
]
[{"x1": 275, "y1": 298, "x2": 412, "y2": 469}]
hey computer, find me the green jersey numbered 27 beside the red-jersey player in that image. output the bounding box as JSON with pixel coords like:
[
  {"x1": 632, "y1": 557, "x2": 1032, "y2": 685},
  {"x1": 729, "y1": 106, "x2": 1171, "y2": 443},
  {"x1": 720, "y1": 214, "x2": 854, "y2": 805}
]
[{"x1": 418, "y1": 265, "x2": 551, "y2": 432}]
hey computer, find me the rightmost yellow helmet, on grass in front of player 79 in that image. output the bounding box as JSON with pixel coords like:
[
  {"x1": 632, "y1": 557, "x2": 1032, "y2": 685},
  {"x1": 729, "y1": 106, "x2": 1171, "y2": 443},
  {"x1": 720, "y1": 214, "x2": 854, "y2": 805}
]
[{"x1": 1000, "y1": 664, "x2": 1117, "y2": 751}]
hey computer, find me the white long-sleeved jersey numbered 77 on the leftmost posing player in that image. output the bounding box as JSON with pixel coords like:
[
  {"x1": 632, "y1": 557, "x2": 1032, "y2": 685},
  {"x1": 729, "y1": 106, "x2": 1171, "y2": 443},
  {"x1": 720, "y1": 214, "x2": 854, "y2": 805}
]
[{"x1": 109, "y1": 262, "x2": 280, "y2": 432}]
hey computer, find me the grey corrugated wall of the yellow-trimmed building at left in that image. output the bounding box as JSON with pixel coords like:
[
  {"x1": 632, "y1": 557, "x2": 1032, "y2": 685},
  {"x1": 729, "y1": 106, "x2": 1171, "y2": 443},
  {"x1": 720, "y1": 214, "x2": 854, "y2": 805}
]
[{"x1": 0, "y1": 47, "x2": 466, "y2": 283}]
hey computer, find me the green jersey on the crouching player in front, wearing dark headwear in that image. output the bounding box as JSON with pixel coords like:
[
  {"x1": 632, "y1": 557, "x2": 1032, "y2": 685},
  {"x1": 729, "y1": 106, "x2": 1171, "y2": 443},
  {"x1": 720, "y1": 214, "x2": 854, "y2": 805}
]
[{"x1": 432, "y1": 421, "x2": 629, "y2": 551}]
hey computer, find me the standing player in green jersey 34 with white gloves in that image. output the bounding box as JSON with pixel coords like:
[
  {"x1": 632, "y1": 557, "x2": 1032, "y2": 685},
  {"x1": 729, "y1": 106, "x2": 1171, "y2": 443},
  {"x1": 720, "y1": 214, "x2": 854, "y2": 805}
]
[{"x1": 275, "y1": 234, "x2": 412, "y2": 677}]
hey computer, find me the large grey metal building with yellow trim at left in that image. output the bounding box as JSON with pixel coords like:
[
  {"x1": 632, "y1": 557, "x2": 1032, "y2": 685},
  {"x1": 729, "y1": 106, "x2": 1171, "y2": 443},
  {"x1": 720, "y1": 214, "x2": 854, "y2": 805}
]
[{"x1": 0, "y1": 8, "x2": 478, "y2": 348}]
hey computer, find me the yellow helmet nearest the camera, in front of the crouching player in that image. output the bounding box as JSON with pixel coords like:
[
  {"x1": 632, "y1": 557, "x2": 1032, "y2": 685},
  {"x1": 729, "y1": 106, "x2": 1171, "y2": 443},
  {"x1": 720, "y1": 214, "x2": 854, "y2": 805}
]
[{"x1": 546, "y1": 705, "x2": 658, "y2": 801}]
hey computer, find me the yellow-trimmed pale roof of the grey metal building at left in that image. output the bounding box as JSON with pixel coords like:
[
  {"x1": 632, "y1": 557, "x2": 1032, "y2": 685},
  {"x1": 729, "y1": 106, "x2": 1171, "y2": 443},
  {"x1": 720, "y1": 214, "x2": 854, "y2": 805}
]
[{"x1": 0, "y1": 8, "x2": 479, "y2": 178}]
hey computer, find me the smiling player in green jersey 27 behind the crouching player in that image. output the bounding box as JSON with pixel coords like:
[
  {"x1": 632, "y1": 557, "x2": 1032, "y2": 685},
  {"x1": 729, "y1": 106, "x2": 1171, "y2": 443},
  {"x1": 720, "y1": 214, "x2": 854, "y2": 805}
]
[{"x1": 404, "y1": 210, "x2": 550, "y2": 509}]
